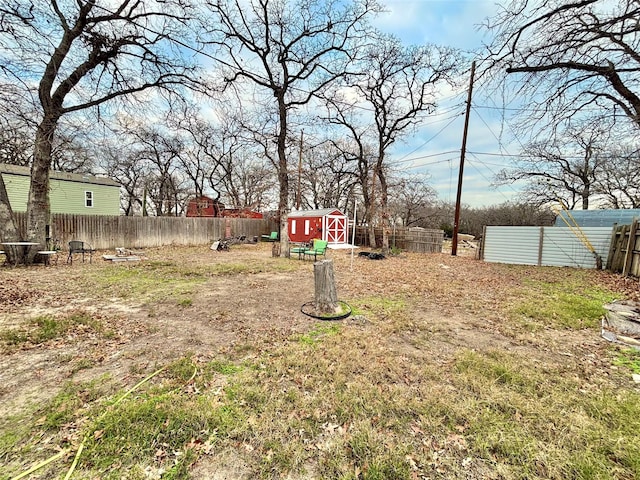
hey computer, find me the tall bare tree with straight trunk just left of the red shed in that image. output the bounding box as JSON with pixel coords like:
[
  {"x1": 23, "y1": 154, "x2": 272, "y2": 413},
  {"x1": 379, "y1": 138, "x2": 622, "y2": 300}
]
[{"x1": 206, "y1": 0, "x2": 379, "y2": 256}]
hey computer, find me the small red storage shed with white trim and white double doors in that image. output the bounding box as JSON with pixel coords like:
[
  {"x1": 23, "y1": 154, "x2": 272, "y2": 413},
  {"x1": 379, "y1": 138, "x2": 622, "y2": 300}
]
[{"x1": 288, "y1": 208, "x2": 349, "y2": 245}]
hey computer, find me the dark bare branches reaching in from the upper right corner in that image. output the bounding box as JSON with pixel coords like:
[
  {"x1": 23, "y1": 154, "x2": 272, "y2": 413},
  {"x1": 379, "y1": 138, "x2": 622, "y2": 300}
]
[{"x1": 486, "y1": 0, "x2": 640, "y2": 131}]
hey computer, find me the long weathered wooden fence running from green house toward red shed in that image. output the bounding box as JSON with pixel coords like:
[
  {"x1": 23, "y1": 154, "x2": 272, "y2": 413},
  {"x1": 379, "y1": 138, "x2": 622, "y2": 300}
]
[{"x1": 15, "y1": 213, "x2": 274, "y2": 250}]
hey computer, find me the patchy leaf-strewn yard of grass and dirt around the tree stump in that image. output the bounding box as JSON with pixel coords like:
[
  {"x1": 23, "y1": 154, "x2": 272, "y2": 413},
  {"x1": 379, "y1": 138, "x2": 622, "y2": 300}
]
[{"x1": 0, "y1": 244, "x2": 640, "y2": 480}]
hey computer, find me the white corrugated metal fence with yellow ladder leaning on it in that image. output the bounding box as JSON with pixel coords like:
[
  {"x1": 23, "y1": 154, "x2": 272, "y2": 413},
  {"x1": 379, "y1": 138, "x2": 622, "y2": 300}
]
[{"x1": 482, "y1": 226, "x2": 612, "y2": 268}]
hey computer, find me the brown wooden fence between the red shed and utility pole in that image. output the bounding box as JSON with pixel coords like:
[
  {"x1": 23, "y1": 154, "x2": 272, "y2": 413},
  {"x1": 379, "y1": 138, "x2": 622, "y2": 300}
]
[{"x1": 349, "y1": 227, "x2": 444, "y2": 253}]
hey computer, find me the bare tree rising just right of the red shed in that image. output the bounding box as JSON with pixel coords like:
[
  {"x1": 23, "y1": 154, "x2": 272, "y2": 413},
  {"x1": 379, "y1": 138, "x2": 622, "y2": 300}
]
[{"x1": 330, "y1": 34, "x2": 461, "y2": 250}]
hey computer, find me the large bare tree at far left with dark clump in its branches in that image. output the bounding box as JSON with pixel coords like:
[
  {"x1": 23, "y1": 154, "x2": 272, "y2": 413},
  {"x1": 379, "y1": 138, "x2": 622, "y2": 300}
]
[{"x1": 0, "y1": 0, "x2": 198, "y2": 256}]
